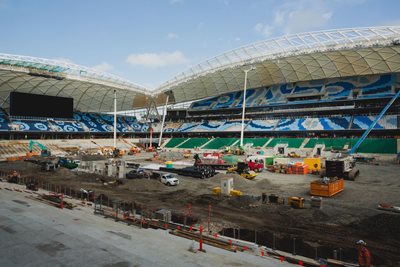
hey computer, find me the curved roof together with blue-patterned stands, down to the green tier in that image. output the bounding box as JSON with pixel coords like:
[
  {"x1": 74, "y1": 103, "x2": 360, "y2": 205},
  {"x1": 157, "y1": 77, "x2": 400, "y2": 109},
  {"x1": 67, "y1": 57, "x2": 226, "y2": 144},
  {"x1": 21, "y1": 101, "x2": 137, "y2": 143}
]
[{"x1": 0, "y1": 26, "x2": 400, "y2": 149}]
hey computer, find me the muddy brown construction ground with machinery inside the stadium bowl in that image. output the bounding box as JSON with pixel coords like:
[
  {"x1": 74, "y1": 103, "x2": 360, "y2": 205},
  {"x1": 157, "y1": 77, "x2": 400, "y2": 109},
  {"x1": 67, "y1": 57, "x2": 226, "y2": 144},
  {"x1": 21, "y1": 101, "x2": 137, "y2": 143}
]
[{"x1": 0, "y1": 136, "x2": 400, "y2": 266}]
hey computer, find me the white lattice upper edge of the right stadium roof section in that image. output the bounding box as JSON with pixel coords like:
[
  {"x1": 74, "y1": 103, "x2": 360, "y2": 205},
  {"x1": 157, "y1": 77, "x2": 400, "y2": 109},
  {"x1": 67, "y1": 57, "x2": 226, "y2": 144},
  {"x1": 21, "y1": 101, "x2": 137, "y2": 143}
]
[{"x1": 152, "y1": 26, "x2": 400, "y2": 94}]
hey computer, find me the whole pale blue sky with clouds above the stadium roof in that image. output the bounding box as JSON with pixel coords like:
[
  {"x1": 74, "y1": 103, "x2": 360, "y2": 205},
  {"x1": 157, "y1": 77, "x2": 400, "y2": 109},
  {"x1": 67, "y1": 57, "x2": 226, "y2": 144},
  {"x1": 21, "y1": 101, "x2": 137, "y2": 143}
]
[{"x1": 0, "y1": 0, "x2": 400, "y2": 88}]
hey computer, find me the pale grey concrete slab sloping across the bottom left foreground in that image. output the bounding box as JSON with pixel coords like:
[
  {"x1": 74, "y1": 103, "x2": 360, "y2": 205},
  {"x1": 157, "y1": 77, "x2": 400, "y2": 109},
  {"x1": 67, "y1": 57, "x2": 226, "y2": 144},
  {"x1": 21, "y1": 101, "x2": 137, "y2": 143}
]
[{"x1": 0, "y1": 190, "x2": 292, "y2": 267}]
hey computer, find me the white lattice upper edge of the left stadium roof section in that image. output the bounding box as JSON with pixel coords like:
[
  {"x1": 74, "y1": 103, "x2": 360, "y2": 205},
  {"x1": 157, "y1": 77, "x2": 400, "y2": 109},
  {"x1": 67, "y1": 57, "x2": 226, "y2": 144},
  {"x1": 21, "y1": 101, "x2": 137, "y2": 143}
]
[{"x1": 0, "y1": 53, "x2": 151, "y2": 95}]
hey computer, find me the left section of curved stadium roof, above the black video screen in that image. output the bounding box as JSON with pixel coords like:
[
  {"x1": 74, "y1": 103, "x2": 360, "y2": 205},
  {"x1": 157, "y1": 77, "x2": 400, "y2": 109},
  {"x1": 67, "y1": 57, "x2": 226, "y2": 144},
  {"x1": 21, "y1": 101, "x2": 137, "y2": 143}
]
[{"x1": 0, "y1": 54, "x2": 150, "y2": 112}]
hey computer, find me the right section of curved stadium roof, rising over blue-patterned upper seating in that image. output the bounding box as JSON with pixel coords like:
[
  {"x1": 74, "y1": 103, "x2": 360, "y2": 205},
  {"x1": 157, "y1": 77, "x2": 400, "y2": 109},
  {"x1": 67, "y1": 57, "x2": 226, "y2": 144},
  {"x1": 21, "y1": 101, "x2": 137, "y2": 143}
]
[{"x1": 155, "y1": 26, "x2": 400, "y2": 102}]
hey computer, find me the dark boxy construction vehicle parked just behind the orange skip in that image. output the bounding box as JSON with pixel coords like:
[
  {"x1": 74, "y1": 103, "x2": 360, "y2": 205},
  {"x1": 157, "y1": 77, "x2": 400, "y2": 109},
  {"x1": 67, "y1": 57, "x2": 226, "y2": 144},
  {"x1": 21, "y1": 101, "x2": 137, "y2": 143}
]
[{"x1": 320, "y1": 155, "x2": 360, "y2": 181}]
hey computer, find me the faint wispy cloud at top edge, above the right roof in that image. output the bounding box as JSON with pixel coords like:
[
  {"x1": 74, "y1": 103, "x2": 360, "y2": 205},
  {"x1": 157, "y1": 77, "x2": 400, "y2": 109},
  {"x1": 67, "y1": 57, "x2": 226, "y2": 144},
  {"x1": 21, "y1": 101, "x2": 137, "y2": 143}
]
[{"x1": 253, "y1": 0, "x2": 336, "y2": 37}]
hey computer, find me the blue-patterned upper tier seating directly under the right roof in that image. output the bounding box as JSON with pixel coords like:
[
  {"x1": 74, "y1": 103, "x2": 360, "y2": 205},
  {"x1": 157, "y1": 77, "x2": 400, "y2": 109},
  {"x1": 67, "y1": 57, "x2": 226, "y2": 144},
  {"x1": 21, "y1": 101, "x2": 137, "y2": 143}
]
[{"x1": 190, "y1": 74, "x2": 396, "y2": 110}]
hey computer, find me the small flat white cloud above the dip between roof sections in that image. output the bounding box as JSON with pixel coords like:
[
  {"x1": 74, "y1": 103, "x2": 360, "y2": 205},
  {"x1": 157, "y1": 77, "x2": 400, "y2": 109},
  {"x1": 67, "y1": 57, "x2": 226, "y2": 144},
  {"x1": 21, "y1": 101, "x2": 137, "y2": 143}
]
[{"x1": 126, "y1": 51, "x2": 189, "y2": 68}]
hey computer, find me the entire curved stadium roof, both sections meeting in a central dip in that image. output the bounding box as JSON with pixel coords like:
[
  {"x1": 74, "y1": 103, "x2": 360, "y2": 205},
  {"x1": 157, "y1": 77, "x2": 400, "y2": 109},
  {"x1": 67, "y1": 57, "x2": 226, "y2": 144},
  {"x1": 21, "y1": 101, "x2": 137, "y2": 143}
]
[{"x1": 0, "y1": 26, "x2": 400, "y2": 112}]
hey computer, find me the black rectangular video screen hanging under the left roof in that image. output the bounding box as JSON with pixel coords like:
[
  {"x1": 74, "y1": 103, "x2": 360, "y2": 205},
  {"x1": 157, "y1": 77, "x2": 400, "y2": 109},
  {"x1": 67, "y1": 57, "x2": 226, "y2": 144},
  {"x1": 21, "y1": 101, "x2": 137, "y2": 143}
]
[{"x1": 10, "y1": 92, "x2": 74, "y2": 119}]
